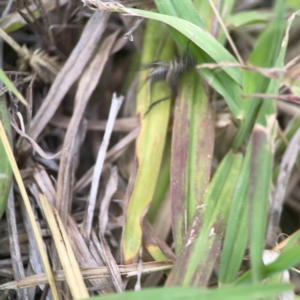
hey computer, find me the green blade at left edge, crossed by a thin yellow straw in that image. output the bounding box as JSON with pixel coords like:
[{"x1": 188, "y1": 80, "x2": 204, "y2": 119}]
[{"x1": 0, "y1": 97, "x2": 12, "y2": 219}]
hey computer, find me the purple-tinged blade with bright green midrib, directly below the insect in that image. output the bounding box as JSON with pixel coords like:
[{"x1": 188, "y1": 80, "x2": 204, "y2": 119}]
[{"x1": 171, "y1": 72, "x2": 214, "y2": 253}]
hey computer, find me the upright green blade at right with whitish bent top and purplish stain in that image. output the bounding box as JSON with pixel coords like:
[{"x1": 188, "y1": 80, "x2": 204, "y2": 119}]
[{"x1": 249, "y1": 6, "x2": 292, "y2": 282}]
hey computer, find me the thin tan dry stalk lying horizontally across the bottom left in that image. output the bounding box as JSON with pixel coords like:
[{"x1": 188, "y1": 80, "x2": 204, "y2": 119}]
[{"x1": 0, "y1": 262, "x2": 173, "y2": 290}]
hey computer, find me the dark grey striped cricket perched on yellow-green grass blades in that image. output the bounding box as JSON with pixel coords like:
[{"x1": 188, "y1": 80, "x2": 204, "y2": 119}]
[{"x1": 144, "y1": 48, "x2": 196, "y2": 116}]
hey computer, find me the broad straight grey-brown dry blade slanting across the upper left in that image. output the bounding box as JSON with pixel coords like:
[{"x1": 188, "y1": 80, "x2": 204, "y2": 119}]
[{"x1": 19, "y1": 11, "x2": 110, "y2": 152}]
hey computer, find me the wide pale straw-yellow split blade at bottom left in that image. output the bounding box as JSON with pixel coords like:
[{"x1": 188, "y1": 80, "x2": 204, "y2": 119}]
[{"x1": 40, "y1": 194, "x2": 89, "y2": 299}]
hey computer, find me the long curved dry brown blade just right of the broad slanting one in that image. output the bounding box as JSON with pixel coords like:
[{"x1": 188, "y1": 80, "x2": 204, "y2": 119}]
[{"x1": 56, "y1": 31, "x2": 119, "y2": 224}]
